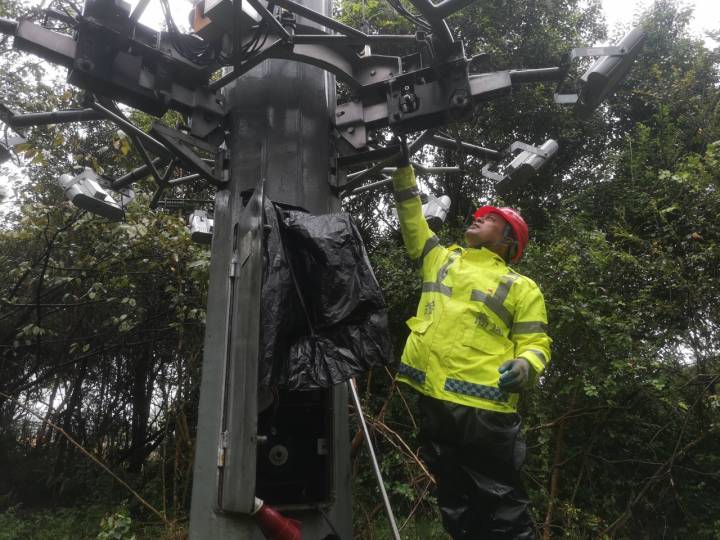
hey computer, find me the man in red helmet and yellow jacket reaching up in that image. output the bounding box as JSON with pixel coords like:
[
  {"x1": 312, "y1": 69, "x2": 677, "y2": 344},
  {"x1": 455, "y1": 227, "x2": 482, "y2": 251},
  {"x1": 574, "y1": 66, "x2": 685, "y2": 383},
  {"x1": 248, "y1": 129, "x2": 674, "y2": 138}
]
[{"x1": 393, "y1": 142, "x2": 551, "y2": 540}]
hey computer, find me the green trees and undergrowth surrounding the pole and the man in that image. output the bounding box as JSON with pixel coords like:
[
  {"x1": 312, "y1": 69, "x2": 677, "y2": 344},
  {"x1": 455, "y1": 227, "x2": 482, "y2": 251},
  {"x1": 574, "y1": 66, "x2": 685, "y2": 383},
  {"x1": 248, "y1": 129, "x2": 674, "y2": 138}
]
[{"x1": 0, "y1": 0, "x2": 720, "y2": 539}]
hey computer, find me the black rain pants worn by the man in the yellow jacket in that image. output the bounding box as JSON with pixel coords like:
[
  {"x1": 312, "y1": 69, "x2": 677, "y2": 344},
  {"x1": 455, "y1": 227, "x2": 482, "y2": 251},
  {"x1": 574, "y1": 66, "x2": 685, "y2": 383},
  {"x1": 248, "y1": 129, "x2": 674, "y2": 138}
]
[{"x1": 419, "y1": 395, "x2": 535, "y2": 540}]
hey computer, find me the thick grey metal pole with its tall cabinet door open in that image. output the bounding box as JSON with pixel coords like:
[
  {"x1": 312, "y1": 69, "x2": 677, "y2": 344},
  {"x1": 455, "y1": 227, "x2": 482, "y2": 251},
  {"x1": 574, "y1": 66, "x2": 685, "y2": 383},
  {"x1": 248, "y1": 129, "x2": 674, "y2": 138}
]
[{"x1": 189, "y1": 0, "x2": 352, "y2": 540}]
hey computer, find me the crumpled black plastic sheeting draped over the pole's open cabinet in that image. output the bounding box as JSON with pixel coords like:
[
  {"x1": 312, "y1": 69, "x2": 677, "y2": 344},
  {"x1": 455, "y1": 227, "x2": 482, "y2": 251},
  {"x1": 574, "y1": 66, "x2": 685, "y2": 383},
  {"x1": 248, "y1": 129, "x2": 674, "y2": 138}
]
[{"x1": 259, "y1": 200, "x2": 392, "y2": 390}]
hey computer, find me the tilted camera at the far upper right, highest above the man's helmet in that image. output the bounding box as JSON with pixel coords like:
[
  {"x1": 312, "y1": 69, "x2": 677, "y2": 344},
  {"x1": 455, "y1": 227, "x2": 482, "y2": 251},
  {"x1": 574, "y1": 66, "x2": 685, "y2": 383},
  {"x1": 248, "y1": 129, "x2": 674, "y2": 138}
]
[{"x1": 575, "y1": 27, "x2": 647, "y2": 117}]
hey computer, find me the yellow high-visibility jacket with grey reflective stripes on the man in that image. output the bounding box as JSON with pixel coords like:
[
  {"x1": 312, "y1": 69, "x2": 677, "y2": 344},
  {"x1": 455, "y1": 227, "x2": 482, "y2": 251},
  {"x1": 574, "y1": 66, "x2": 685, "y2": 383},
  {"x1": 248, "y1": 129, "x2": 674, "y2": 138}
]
[{"x1": 393, "y1": 167, "x2": 551, "y2": 413}]
